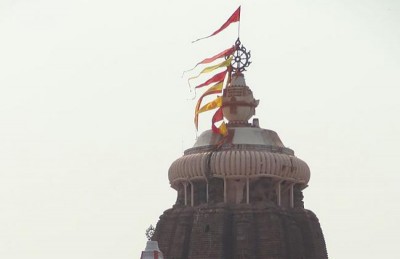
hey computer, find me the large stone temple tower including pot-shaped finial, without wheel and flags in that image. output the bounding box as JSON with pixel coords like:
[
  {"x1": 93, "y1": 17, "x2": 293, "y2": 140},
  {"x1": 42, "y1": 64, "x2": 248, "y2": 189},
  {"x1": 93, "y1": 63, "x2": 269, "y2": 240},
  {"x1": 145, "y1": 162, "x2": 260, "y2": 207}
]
[{"x1": 152, "y1": 62, "x2": 328, "y2": 259}]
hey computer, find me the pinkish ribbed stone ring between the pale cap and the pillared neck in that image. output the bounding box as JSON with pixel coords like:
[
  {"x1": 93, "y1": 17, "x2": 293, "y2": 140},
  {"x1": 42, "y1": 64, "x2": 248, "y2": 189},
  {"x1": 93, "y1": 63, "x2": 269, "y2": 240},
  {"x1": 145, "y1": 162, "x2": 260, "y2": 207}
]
[{"x1": 168, "y1": 150, "x2": 310, "y2": 186}]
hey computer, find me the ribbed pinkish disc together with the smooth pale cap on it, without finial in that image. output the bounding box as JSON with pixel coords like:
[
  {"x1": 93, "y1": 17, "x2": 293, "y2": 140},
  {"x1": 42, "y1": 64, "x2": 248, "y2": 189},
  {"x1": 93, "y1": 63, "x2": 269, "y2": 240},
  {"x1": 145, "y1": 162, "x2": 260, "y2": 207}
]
[{"x1": 168, "y1": 127, "x2": 310, "y2": 187}]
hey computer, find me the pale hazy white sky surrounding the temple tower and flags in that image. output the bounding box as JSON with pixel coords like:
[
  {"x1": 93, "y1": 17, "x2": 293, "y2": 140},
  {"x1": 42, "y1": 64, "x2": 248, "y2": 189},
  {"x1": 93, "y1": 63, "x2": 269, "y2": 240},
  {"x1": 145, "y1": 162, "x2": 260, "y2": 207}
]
[{"x1": 0, "y1": 0, "x2": 400, "y2": 259}]
